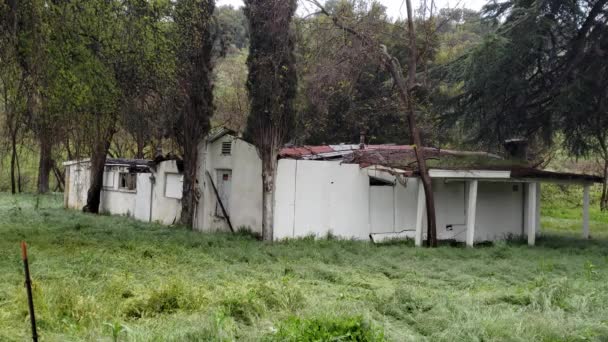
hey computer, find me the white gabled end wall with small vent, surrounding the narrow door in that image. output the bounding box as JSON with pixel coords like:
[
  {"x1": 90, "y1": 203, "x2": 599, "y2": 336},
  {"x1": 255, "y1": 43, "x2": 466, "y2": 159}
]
[{"x1": 196, "y1": 135, "x2": 262, "y2": 233}]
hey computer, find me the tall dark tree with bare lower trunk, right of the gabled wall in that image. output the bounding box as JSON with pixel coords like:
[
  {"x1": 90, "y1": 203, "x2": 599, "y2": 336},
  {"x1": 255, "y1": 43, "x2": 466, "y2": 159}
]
[{"x1": 245, "y1": 0, "x2": 297, "y2": 241}]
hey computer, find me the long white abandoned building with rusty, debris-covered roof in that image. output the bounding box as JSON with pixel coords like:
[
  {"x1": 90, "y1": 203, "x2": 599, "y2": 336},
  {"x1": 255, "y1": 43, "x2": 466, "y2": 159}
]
[{"x1": 64, "y1": 129, "x2": 601, "y2": 246}]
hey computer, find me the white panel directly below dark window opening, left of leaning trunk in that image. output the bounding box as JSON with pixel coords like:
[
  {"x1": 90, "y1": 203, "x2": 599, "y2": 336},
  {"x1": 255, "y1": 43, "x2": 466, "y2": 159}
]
[{"x1": 369, "y1": 185, "x2": 395, "y2": 233}]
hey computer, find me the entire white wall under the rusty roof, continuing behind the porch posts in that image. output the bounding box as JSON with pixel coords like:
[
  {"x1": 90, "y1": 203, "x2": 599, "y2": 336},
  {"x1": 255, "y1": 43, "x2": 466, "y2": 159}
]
[{"x1": 275, "y1": 159, "x2": 523, "y2": 241}]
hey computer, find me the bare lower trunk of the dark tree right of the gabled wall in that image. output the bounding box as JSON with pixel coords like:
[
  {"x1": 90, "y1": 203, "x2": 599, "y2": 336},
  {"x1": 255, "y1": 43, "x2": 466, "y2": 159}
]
[{"x1": 262, "y1": 152, "x2": 277, "y2": 241}]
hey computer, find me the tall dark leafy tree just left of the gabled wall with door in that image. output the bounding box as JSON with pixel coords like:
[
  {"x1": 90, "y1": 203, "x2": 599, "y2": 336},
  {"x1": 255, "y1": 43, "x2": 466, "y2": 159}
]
[{"x1": 175, "y1": 0, "x2": 215, "y2": 226}]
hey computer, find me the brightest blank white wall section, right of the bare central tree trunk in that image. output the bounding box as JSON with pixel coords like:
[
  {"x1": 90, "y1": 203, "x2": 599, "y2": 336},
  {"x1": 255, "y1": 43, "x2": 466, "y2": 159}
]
[{"x1": 274, "y1": 159, "x2": 370, "y2": 240}]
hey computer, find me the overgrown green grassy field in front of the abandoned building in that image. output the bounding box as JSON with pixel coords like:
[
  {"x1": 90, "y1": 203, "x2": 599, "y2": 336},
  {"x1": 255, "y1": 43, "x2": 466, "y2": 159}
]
[{"x1": 0, "y1": 191, "x2": 608, "y2": 341}]
